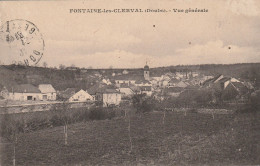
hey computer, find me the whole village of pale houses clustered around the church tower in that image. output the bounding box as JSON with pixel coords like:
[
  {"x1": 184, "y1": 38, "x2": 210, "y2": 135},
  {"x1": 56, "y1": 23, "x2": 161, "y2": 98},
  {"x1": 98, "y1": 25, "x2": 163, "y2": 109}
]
[{"x1": 0, "y1": 64, "x2": 254, "y2": 110}]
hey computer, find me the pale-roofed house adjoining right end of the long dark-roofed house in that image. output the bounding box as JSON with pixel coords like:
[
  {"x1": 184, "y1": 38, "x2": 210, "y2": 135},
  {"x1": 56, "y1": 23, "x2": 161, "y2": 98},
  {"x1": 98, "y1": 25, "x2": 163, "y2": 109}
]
[{"x1": 38, "y1": 84, "x2": 57, "y2": 100}]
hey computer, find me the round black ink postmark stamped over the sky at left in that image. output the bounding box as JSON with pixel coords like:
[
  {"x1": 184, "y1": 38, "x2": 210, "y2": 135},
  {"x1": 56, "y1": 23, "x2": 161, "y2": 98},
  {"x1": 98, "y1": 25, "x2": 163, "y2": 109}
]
[{"x1": 0, "y1": 19, "x2": 44, "y2": 66}]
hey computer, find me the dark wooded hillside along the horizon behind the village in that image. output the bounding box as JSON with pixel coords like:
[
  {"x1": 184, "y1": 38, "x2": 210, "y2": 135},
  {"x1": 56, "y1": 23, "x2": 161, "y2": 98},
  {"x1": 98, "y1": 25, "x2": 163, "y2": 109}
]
[{"x1": 0, "y1": 63, "x2": 260, "y2": 90}]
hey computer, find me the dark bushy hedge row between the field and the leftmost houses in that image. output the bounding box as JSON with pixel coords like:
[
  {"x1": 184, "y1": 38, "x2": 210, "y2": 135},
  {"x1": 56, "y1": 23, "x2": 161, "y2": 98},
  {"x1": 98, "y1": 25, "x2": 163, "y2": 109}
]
[{"x1": 0, "y1": 107, "x2": 124, "y2": 140}]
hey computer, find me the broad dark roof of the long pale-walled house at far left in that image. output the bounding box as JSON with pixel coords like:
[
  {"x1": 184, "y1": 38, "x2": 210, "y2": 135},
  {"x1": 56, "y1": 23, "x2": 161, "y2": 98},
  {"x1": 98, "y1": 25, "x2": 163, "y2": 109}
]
[{"x1": 8, "y1": 84, "x2": 41, "y2": 93}]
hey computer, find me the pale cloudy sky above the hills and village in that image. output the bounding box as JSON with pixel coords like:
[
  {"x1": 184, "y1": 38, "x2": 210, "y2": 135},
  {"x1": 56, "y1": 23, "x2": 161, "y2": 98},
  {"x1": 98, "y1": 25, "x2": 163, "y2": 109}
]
[{"x1": 0, "y1": 0, "x2": 260, "y2": 68}]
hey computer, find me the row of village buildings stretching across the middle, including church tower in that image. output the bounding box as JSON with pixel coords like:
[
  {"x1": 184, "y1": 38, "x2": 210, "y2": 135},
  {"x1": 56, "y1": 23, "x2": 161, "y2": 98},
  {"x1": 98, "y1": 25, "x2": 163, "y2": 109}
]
[{"x1": 0, "y1": 65, "x2": 253, "y2": 106}]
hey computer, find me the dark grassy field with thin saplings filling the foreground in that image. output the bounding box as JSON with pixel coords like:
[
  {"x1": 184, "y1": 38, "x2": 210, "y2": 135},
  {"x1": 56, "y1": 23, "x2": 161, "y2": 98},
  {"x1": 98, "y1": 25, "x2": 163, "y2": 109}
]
[{"x1": 0, "y1": 112, "x2": 260, "y2": 165}]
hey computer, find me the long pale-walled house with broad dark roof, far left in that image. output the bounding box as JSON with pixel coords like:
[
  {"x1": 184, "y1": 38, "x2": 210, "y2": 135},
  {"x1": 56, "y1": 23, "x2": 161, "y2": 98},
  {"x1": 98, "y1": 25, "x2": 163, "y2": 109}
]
[{"x1": 8, "y1": 84, "x2": 42, "y2": 101}]
